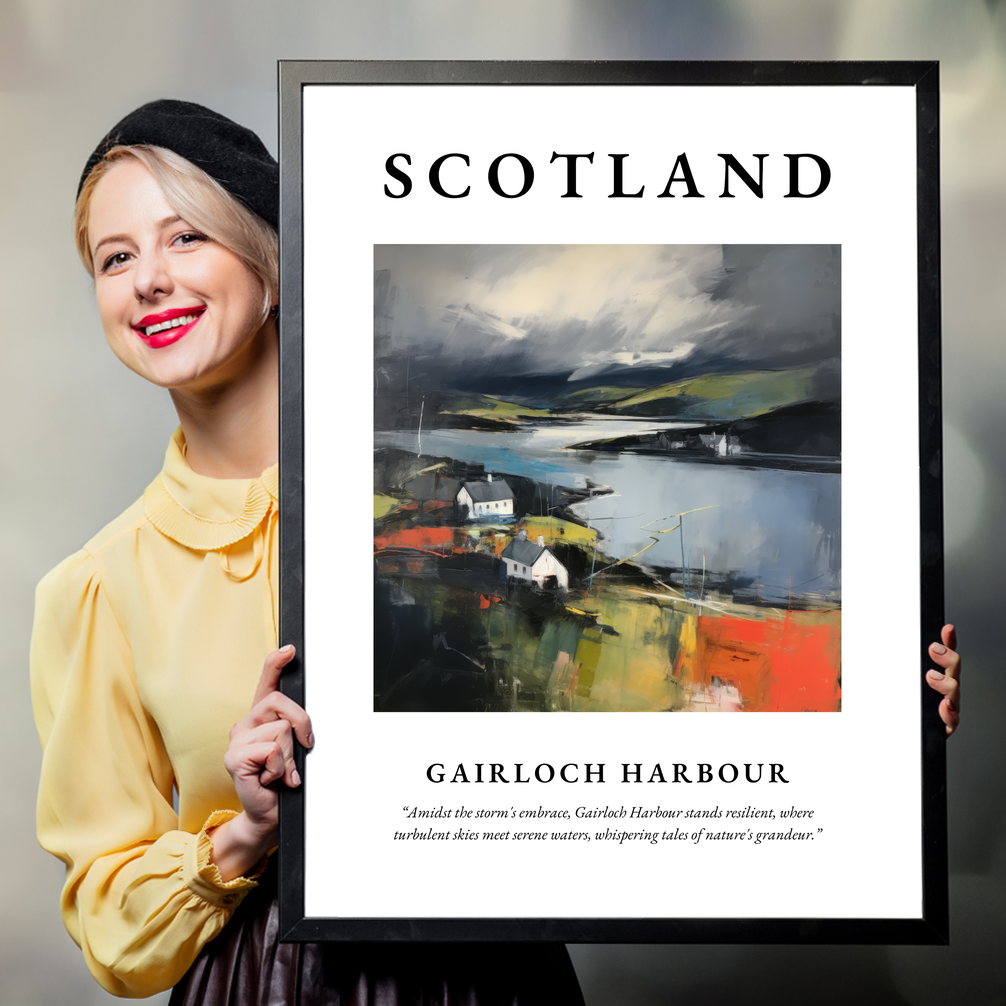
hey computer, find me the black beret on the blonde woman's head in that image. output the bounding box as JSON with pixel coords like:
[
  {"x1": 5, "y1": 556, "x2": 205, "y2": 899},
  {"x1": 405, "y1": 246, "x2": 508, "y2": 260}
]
[{"x1": 76, "y1": 99, "x2": 280, "y2": 227}]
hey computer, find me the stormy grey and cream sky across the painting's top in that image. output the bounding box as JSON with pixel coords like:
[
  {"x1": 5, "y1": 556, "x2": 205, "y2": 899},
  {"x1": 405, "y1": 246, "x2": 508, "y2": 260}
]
[{"x1": 374, "y1": 244, "x2": 841, "y2": 389}]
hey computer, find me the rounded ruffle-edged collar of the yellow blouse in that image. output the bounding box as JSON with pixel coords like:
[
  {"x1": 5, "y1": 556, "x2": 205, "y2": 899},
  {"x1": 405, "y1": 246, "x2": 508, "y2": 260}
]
[{"x1": 143, "y1": 427, "x2": 280, "y2": 551}]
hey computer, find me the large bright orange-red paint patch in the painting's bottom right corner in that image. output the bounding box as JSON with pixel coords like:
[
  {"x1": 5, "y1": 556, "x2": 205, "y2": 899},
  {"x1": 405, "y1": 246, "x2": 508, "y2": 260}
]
[{"x1": 692, "y1": 612, "x2": 842, "y2": 712}]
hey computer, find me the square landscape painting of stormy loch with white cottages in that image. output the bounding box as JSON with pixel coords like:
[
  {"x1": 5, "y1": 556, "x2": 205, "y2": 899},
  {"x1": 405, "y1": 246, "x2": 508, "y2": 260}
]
[{"x1": 373, "y1": 244, "x2": 842, "y2": 712}]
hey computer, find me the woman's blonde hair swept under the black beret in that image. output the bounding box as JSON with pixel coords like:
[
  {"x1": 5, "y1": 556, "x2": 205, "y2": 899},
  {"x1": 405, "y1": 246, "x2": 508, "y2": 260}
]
[{"x1": 73, "y1": 145, "x2": 280, "y2": 323}]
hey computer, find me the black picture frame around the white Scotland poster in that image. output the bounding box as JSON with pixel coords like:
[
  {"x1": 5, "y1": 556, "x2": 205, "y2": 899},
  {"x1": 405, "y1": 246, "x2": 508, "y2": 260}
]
[{"x1": 279, "y1": 61, "x2": 949, "y2": 944}]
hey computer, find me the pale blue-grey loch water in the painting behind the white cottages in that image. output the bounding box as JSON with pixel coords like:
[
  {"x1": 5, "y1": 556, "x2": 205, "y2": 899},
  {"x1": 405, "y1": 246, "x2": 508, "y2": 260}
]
[{"x1": 374, "y1": 415, "x2": 842, "y2": 604}]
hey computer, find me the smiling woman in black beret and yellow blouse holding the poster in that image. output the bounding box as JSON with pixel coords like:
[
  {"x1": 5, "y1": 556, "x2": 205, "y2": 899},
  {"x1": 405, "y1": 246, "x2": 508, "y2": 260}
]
[{"x1": 31, "y1": 102, "x2": 582, "y2": 1006}]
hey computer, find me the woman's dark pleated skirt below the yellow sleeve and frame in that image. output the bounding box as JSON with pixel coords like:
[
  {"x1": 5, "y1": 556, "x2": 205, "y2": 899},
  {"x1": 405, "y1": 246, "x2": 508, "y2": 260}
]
[{"x1": 170, "y1": 870, "x2": 583, "y2": 1006}]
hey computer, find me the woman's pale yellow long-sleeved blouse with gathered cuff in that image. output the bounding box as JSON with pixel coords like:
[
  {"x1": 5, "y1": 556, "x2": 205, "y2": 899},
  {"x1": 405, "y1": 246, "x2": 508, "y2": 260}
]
[{"x1": 31, "y1": 430, "x2": 278, "y2": 997}]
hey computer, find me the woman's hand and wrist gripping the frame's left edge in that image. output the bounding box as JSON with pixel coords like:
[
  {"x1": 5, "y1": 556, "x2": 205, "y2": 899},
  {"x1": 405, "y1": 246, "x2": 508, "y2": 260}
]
[{"x1": 209, "y1": 646, "x2": 314, "y2": 880}]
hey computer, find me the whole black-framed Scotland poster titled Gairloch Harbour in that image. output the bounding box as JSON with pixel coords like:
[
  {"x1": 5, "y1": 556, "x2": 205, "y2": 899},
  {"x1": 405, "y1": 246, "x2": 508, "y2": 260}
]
[{"x1": 280, "y1": 62, "x2": 948, "y2": 943}]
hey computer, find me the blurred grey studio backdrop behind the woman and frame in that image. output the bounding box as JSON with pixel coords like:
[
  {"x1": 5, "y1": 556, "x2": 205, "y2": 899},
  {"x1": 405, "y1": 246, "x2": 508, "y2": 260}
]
[{"x1": 0, "y1": 0, "x2": 1006, "y2": 1006}]
